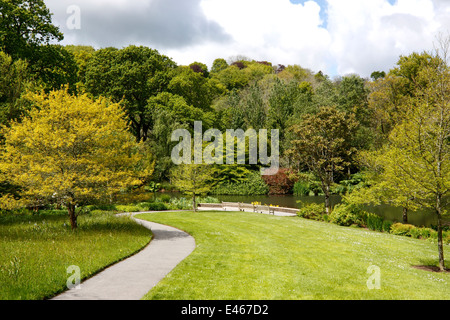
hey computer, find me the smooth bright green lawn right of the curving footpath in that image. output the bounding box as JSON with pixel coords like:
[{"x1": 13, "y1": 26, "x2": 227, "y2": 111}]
[{"x1": 138, "y1": 212, "x2": 450, "y2": 300}]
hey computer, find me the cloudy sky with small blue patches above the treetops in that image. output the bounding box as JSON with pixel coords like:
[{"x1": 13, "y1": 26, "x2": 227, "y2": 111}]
[{"x1": 44, "y1": 0, "x2": 450, "y2": 77}]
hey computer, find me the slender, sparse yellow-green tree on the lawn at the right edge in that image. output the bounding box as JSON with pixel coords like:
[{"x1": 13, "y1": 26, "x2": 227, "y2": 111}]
[{"x1": 389, "y1": 58, "x2": 450, "y2": 271}]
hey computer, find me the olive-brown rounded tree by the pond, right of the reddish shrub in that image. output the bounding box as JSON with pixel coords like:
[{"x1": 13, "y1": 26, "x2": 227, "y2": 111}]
[{"x1": 288, "y1": 107, "x2": 358, "y2": 213}]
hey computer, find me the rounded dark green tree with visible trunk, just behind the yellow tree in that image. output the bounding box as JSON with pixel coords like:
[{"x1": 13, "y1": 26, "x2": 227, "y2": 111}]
[{"x1": 85, "y1": 46, "x2": 176, "y2": 141}]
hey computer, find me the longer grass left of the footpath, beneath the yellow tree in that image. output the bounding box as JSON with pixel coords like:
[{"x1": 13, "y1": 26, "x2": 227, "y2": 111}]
[{"x1": 0, "y1": 211, "x2": 151, "y2": 300}]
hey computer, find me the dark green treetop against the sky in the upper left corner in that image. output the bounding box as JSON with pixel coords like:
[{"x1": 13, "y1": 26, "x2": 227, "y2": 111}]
[{"x1": 0, "y1": 0, "x2": 77, "y2": 91}]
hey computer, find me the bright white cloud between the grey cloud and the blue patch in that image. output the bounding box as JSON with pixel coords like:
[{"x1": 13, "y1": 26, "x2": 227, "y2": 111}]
[{"x1": 196, "y1": 0, "x2": 331, "y2": 71}]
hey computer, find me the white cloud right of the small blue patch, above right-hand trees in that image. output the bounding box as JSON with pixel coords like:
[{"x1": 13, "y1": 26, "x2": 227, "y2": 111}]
[{"x1": 328, "y1": 0, "x2": 449, "y2": 76}]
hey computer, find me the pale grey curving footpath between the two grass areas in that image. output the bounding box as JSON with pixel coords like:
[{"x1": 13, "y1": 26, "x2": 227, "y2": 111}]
[{"x1": 51, "y1": 212, "x2": 195, "y2": 300}]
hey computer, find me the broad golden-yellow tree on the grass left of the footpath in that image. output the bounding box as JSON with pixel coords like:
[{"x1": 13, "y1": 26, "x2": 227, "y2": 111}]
[{"x1": 0, "y1": 89, "x2": 153, "y2": 229}]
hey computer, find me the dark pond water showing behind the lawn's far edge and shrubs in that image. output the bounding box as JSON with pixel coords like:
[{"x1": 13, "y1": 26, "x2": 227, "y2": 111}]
[{"x1": 162, "y1": 194, "x2": 437, "y2": 227}]
